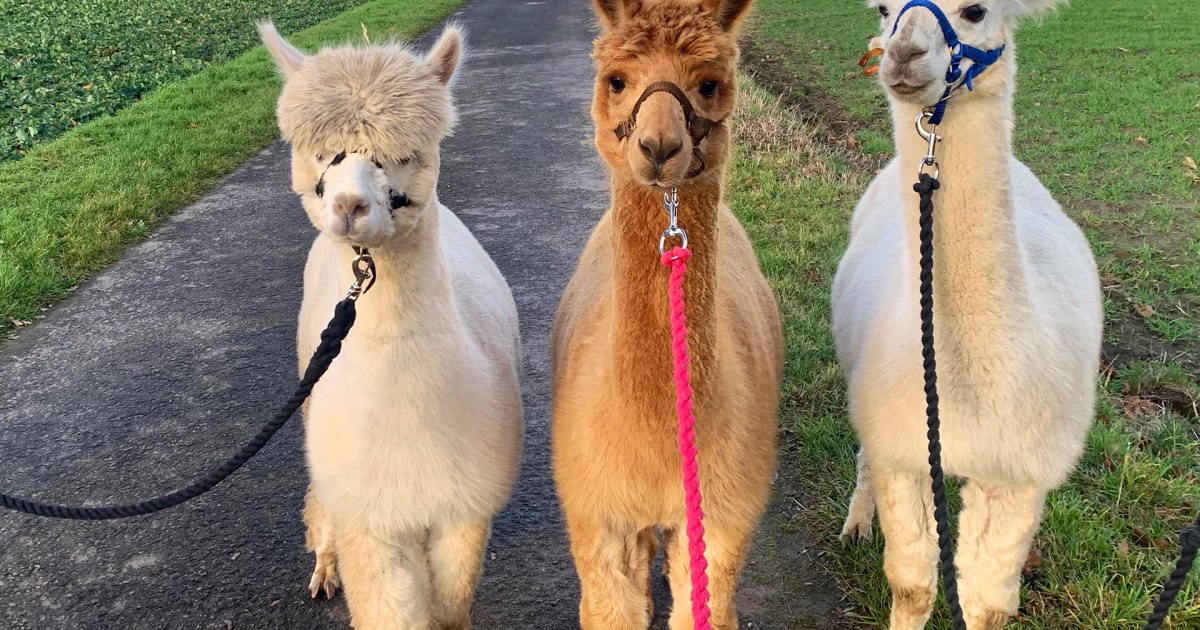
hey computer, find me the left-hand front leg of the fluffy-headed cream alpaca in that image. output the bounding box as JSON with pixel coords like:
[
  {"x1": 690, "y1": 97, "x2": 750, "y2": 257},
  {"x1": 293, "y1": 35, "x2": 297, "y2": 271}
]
[{"x1": 334, "y1": 522, "x2": 433, "y2": 630}]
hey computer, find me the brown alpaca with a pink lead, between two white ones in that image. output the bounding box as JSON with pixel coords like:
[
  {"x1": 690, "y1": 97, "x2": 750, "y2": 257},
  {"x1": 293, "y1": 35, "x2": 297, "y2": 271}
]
[{"x1": 551, "y1": 0, "x2": 782, "y2": 630}]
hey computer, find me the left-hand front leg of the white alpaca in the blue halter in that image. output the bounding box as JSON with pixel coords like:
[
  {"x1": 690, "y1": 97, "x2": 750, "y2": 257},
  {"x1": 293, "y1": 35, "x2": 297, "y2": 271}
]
[{"x1": 872, "y1": 470, "x2": 937, "y2": 630}]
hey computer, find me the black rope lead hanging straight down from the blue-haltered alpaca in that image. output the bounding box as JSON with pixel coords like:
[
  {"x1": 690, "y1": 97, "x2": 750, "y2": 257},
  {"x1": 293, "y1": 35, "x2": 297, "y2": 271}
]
[{"x1": 912, "y1": 173, "x2": 967, "y2": 630}]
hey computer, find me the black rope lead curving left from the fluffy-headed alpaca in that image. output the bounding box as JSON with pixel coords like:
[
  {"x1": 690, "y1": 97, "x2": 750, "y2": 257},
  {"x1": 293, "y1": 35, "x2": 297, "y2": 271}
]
[{"x1": 0, "y1": 295, "x2": 356, "y2": 521}]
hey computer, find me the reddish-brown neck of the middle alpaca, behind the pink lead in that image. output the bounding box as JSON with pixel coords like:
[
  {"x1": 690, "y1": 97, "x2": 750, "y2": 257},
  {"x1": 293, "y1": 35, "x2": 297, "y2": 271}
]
[{"x1": 612, "y1": 173, "x2": 721, "y2": 405}]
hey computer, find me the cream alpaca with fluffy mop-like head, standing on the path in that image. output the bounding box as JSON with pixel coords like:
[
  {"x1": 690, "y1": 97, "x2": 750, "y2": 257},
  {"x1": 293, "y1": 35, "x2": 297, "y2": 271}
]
[{"x1": 259, "y1": 23, "x2": 522, "y2": 630}]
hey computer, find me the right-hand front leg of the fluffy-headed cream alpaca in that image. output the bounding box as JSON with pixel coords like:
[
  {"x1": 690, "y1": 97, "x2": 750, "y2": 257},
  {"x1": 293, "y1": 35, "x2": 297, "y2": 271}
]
[{"x1": 428, "y1": 517, "x2": 492, "y2": 630}]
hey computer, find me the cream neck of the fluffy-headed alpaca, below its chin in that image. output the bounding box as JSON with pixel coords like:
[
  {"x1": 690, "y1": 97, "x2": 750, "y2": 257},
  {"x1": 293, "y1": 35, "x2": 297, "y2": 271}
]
[{"x1": 346, "y1": 197, "x2": 463, "y2": 340}]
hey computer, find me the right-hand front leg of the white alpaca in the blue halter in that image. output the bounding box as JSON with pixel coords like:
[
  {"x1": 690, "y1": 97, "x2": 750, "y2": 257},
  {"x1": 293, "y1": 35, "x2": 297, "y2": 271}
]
[{"x1": 955, "y1": 480, "x2": 1045, "y2": 630}]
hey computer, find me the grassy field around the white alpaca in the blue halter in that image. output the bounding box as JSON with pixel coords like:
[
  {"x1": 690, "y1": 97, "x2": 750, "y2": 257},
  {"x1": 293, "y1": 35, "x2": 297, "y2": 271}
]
[{"x1": 731, "y1": 0, "x2": 1200, "y2": 629}]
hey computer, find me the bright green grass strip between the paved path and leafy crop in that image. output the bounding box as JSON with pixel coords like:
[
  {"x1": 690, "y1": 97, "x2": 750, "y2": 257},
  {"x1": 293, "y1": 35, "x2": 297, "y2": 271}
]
[{"x1": 0, "y1": 0, "x2": 461, "y2": 332}]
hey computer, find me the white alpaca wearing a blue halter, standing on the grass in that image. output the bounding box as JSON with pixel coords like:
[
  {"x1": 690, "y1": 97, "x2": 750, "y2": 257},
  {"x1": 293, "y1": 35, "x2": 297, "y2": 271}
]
[{"x1": 833, "y1": 0, "x2": 1103, "y2": 630}]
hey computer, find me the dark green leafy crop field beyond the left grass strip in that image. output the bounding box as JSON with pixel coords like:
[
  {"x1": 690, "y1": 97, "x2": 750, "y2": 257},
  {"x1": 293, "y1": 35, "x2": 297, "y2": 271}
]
[{"x1": 0, "y1": 0, "x2": 374, "y2": 161}]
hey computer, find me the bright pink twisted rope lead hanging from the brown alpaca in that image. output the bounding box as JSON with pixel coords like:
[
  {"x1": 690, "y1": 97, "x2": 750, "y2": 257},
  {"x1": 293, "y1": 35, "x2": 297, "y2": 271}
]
[{"x1": 662, "y1": 247, "x2": 712, "y2": 630}]
